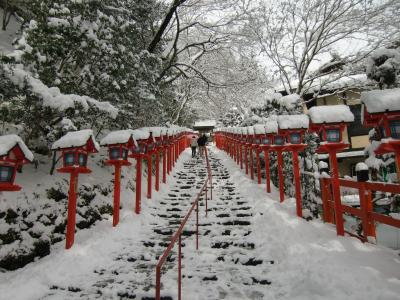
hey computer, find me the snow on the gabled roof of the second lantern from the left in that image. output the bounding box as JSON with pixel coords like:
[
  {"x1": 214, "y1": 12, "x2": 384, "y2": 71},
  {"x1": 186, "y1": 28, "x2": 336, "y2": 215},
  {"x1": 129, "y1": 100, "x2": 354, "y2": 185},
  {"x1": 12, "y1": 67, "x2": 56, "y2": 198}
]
[{"x1": 51, "y1": 129, "x2": 100, "y2": 151}]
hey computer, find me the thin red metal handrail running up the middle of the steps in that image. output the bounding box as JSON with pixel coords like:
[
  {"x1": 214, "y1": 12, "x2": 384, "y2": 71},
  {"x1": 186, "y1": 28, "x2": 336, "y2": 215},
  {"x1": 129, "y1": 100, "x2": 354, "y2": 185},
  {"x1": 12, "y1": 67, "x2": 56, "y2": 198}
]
[{"x1": 155, "y1": 148, "x2": 212, "y2": 300}]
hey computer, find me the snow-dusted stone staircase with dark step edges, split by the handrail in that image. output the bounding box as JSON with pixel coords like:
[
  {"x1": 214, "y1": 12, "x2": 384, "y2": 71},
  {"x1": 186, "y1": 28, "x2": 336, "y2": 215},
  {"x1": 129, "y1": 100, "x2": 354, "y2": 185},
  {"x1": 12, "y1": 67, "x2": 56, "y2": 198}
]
[{"x1": 39, "y1": 152, "x2": 273, "y2": 300}]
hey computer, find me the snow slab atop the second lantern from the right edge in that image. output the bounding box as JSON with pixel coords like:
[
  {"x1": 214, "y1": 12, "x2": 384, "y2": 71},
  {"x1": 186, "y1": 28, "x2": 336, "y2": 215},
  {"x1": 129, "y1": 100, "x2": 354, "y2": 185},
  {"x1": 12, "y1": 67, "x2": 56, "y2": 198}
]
[{"x1": 307, "y1": 104, "x2": 354, "y2": 124}]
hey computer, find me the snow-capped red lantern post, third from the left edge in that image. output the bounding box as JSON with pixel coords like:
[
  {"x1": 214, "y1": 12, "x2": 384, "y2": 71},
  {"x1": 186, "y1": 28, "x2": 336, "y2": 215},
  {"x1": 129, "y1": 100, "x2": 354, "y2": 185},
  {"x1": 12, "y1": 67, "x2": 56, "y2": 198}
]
[{"x1": 100, "y1": 130, "x2": 136, "y2": 226}]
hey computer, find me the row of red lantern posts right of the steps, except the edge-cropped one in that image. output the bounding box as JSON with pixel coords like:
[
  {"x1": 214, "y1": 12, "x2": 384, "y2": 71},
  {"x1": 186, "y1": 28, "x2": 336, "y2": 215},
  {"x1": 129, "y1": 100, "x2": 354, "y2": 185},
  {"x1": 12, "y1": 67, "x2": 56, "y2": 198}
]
[{"x1": 215, "y1": 107, "x2": 352, "y2": 235}]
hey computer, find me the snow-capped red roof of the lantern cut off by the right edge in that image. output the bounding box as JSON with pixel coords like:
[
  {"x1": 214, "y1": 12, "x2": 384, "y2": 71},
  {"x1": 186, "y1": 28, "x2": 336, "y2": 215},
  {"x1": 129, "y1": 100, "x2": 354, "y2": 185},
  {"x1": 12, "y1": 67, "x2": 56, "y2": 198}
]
[{"x1": 361, "y1": 88, "x2": 400, "y2": 126}]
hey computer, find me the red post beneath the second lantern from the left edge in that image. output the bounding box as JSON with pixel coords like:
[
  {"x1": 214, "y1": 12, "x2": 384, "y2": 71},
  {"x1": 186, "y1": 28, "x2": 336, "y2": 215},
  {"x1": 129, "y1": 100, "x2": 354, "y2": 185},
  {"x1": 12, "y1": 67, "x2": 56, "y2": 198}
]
[{"x1": 65, "y1": 170, "x2": 79, "y2": 249}]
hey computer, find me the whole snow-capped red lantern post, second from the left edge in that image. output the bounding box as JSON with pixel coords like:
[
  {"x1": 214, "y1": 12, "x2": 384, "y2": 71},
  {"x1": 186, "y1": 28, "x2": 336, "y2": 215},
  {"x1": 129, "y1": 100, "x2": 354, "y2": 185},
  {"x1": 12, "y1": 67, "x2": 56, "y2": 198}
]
[{"x1": 52, "y1": 129, "x2": 99, "y2": 249}]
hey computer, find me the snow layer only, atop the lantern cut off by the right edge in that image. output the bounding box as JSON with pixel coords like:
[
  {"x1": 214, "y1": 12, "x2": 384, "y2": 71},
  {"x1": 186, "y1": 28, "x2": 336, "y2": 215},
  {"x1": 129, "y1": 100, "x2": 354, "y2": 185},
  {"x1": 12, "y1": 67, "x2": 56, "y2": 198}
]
[{"x1": 361, "y1": 88, "x2": 400, "y2": 114}]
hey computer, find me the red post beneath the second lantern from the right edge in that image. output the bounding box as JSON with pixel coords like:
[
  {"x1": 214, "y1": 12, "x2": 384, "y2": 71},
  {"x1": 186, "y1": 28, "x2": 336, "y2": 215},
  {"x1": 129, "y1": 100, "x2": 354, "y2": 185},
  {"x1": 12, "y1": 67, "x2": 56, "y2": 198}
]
[{"x1": 329, "y1": 151, "x2": 344, "y2": 235}]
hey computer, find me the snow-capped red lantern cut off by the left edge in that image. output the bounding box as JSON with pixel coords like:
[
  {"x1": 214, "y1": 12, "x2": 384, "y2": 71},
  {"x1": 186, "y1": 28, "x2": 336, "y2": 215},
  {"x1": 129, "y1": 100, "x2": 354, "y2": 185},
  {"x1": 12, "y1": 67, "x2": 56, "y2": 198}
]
[{"x1": 0, "y1": 134, "x2": 33, "y2": 192}]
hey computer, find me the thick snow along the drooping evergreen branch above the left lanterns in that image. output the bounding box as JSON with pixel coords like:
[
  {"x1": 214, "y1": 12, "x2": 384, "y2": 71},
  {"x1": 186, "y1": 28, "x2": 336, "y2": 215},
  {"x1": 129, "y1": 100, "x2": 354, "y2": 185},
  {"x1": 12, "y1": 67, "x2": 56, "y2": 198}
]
[{"x1": 4, "y1": 65, "x2": 118, "y2": 119}]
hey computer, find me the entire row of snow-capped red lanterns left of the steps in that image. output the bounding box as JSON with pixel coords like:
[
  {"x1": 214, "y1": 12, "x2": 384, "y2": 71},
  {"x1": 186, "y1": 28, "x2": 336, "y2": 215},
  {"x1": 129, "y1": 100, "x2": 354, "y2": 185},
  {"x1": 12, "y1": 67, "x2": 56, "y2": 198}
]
[{"x1": 0, "y1": 127, "x2": 193, "y2": 249}]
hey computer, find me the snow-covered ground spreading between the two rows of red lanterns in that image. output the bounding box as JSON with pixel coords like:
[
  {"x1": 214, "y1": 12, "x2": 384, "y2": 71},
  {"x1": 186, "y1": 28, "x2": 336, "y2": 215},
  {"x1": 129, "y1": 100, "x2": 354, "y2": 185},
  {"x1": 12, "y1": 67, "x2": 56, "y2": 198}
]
[{"x1": 0, "y1": 148, "x2": 400, "y2": 300}]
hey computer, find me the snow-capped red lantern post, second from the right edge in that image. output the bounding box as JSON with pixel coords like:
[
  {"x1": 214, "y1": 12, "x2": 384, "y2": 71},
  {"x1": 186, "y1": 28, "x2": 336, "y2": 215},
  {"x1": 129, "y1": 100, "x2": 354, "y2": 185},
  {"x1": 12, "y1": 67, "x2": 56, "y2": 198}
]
[{"x1": 308, "y1": 105, "x2": 354, "y2": 235}]
